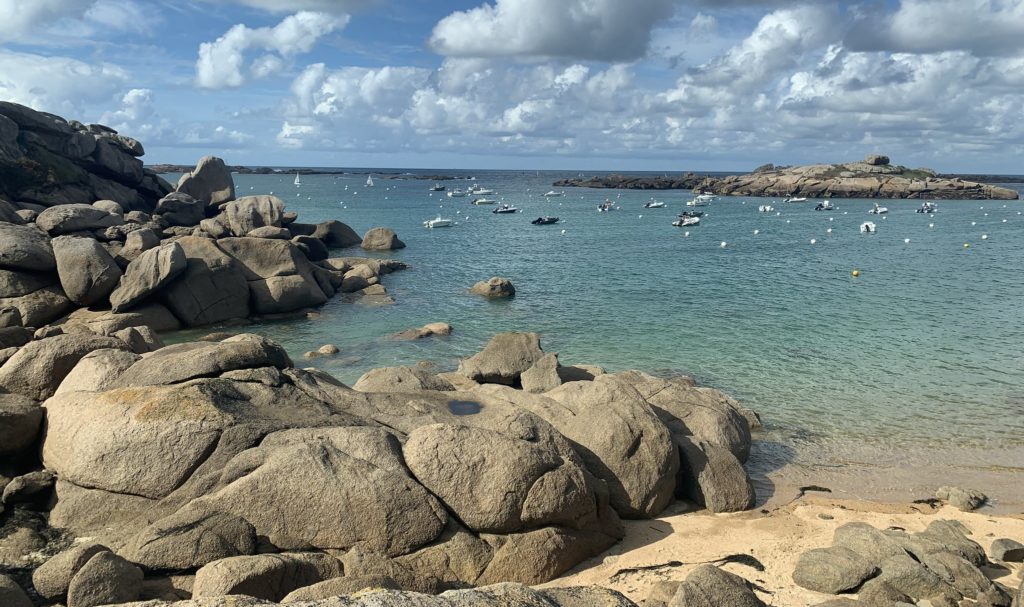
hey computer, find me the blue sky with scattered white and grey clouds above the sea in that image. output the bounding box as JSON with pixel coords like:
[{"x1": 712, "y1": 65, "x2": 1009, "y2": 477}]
[{"x1": 0, "y1": 0, "x2": 1024, "y2": 169}]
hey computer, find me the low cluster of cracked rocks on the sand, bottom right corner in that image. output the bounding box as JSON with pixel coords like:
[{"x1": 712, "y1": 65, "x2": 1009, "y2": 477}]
[{"x1": 793, "y1": 520, "x2": 1024, "y2": 607}]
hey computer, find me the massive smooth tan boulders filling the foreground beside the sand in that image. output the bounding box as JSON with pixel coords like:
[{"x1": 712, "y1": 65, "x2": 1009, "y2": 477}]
[{"x1": 0, "y1": 329, "x2": 757, "y2": 607}]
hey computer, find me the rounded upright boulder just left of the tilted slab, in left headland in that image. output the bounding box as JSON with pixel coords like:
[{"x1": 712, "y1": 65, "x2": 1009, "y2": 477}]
[{"x1": 53, "y1": 236, "x2": 121, "y2": 306}]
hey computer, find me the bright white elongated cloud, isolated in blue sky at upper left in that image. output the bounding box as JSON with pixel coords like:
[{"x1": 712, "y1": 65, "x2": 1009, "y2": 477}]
[{"x1": 196, "y1": 11, "x2": 349, "y2": 88}]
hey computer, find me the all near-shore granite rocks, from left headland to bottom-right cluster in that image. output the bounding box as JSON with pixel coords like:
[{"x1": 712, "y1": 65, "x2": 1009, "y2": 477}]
[{"x1": 0, "y1": 104, "x2": 1024, "y2": 607}]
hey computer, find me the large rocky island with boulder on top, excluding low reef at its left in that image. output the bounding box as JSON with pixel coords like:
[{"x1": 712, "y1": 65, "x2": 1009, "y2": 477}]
[{"x1": 694, "y1": 155, "x2": 1019, "y2": 201}]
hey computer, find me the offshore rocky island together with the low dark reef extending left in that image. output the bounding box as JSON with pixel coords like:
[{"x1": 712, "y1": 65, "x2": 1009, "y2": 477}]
[{"x1": 554, "y1": 155, "x2": 1019, "y2": 201}]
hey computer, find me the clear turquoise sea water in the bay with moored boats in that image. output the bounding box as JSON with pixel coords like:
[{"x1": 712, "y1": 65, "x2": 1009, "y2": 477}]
[{"x1": 172, "y1": 172, "x2": 1024, "y2": 502}]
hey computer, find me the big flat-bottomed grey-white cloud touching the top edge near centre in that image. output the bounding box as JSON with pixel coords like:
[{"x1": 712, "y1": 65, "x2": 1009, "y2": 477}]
[{"x1": 429, "y1": 0, "x2": 674, "y2": 61}]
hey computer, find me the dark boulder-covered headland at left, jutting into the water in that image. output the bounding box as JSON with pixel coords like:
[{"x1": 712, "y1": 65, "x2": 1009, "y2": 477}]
[{"x1": 0, "y1": 103, "x2": 403, "y2": 331}]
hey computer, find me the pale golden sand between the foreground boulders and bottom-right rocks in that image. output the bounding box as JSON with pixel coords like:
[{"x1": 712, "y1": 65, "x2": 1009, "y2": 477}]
[{"x1": 545, "y1": 493, "x2": 1024, "y2": 607}]
